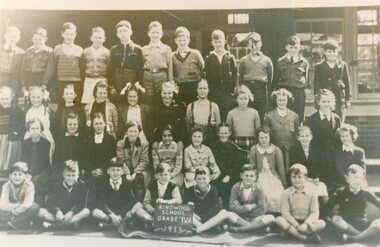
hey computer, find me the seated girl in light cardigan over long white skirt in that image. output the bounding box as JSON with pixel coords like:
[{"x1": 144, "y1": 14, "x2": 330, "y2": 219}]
[{"x1": 249, "y1": 128, "x2": 286, "y2": 213}]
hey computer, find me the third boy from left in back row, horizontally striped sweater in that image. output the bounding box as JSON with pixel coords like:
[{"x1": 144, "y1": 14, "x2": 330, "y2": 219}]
[{"x1": 51, "y1": 22, "x2": 84, "y2": 105}]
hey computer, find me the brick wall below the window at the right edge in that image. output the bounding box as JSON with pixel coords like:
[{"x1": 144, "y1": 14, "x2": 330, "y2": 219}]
[{"x1": 346, "y1": 116, "x2": 380, "y2": 159}]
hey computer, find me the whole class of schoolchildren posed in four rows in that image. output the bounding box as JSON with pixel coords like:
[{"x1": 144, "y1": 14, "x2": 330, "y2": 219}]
[{"x1": 0, "y1": 18, "x2": 380, "y2": 243}]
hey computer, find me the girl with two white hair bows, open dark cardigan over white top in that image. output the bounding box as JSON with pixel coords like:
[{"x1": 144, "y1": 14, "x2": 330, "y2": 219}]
[{"x1": 118, "y1": 82, "x2": 152, "y2": 141}]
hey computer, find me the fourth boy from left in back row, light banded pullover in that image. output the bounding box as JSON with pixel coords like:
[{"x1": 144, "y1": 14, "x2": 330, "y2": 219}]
[{"x1": 79, "y1": 27, "x2": 110, "y2": 104}]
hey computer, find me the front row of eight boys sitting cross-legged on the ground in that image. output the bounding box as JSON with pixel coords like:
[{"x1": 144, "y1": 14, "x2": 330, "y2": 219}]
[{"x1": 0, "y1": 158, "x2": 380, "y2": 243}]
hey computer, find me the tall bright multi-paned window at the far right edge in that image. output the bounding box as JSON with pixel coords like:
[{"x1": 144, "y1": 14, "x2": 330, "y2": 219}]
[{"x1": 356, "y1": 9, "x2": 380, "y2": 94}]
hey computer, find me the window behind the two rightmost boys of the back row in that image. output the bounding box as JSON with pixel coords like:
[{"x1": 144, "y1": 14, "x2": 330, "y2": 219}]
[{"x1": 296, "y1": 19, "x2": 343, "y2": 97}]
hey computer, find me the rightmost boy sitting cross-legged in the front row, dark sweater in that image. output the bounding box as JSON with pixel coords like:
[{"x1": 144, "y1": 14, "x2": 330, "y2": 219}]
[{"x1": 327, "y1": 164, "x2": 380, "y2": 243}]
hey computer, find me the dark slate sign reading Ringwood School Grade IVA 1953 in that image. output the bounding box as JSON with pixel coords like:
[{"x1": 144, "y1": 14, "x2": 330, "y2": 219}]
[{"x1": 153, "y1": 203, "x2": 194, "y2": 236}]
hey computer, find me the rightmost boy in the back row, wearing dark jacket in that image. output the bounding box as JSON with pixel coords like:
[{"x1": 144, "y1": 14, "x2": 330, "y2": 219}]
[{"x1": 314, "y1": 40, "x2": 351, "y2": 122}]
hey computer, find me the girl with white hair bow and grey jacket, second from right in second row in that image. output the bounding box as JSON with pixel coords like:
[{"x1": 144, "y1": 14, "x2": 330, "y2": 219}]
[{"x1": 264, "y1": 88, "x2": 300, "y2": 174}]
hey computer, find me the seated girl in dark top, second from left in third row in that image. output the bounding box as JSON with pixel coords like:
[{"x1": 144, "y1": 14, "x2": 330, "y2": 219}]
[{"x1": 53, "y1": 113, "x2": 85, "y2": 177}]
